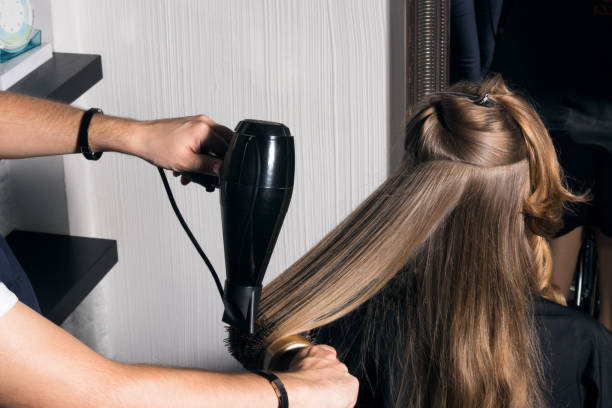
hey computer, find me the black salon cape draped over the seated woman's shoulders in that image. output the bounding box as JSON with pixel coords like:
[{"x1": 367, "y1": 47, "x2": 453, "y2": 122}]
[{"x1": 315, "y1": 298, "x2": 612, "y2": 408}]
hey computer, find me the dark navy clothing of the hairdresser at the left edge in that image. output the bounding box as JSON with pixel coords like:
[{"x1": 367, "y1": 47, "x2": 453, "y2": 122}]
[{"x1": 0, "y1": 236, "x2": 40, "y2": 313}]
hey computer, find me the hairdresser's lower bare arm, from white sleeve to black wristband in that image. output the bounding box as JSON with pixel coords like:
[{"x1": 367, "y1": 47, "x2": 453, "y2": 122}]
[{"x1": 0, "y1": 302, "x2": 280, "y2": 408}]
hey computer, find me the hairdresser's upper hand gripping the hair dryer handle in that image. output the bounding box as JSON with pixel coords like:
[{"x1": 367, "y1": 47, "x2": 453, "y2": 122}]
[{"x1": 128, "y1": 115, "x2": 233, "y2": 176}]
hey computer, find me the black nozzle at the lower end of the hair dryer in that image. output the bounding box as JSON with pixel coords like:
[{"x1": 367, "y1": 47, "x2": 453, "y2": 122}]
[{"x1": 222, "y1": 280, "x2": 261, "y2": 334}]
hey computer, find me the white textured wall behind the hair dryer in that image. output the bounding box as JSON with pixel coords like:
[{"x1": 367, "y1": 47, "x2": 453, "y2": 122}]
[{"x1": 53, "y1": 0, "x2": 396, "y2": 369}]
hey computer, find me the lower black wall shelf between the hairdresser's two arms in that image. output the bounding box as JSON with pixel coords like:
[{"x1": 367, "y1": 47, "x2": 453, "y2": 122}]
[{"x1": 6, "y1": 230, "x2": 118, "y2": 325}]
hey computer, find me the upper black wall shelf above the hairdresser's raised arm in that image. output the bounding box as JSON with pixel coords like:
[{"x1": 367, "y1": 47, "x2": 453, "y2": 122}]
[{"x1": 8, "y1": 52, "x2": 102, "y2": 104}]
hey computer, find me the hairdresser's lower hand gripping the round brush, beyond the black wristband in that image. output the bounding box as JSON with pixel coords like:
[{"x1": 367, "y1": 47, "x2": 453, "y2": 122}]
[{"x1": 277, "y1": 345, "x2": 359, "y2": 408}]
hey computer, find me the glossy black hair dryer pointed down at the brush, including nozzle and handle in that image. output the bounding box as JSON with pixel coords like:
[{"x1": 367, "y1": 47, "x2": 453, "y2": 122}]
[{"x1": 186, "y1": 119, "x2": 295, "y2": 333}]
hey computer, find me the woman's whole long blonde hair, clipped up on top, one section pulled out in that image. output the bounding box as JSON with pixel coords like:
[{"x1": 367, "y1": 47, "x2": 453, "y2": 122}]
[{"x1": 230, "y1": 76, "x2": 582, "y2": 408}]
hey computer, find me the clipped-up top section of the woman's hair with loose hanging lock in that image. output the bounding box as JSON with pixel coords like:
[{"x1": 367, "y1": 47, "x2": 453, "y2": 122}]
[{"x1": 405, "y1": 75, "x2": 584, "y2": 303}]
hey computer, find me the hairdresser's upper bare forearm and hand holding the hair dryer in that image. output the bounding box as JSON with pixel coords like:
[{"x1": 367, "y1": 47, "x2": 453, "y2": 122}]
[{"x1": 0, "y1": 92, "x2": 233, "y2": 175}]
